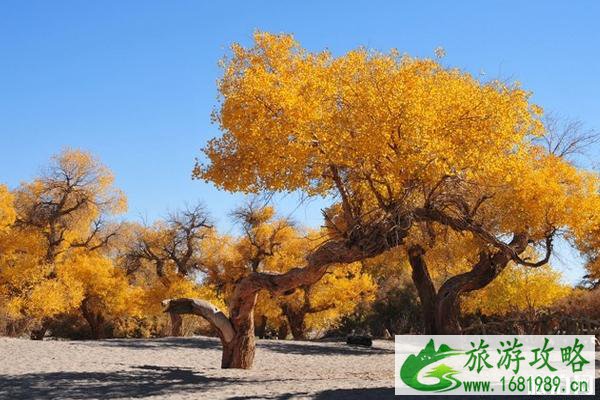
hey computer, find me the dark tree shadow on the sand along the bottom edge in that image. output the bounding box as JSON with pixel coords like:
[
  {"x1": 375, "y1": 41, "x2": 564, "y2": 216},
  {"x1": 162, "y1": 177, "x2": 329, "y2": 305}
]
[{"x1": 0, "y1": 365, "x2": 600, "y2": 400}]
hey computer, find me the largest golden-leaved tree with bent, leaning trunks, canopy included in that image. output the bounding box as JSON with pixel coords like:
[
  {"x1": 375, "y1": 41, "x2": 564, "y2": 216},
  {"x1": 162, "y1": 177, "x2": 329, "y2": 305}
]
[{"x1": 170, "y1": 32, "x2": 600, "y2": 368}]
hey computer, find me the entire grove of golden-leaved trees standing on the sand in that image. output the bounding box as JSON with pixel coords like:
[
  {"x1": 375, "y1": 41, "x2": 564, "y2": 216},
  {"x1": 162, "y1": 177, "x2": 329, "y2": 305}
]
[{"x1": 0, "y1": 32, "x2": 600, "y2": 368}]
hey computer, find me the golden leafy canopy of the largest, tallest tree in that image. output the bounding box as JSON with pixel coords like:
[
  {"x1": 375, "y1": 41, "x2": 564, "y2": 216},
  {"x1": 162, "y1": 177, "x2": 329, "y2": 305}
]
[{"x1": 195, "y1": 32, "x2": 598, "y2": 247}]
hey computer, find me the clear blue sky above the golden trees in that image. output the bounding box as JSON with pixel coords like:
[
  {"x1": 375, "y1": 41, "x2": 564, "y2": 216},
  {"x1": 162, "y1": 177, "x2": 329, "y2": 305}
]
[{"x1": 0, "y1": 0, "x2": 600, "y2": 281}]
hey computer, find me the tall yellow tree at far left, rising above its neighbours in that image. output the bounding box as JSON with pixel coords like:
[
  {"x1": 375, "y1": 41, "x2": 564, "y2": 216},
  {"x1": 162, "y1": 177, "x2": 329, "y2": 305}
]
[{"x1": 0, "y1": 150, "x2": 135, "y2": 338}]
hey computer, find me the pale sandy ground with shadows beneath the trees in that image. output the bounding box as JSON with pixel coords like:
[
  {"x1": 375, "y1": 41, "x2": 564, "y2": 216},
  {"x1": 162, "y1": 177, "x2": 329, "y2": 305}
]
[{"x1": 0, "y1": 337, "x2": 600, "y2": 400}]
